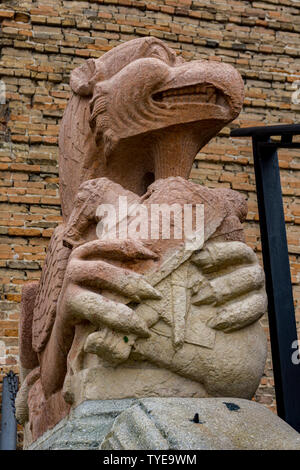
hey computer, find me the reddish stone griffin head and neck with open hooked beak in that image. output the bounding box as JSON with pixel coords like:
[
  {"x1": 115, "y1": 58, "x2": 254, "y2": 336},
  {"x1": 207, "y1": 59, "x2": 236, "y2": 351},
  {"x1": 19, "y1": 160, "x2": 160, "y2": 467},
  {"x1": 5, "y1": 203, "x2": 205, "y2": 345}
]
[{"x1": 60, "y1": 38, "x2": 244, "y2": 218}]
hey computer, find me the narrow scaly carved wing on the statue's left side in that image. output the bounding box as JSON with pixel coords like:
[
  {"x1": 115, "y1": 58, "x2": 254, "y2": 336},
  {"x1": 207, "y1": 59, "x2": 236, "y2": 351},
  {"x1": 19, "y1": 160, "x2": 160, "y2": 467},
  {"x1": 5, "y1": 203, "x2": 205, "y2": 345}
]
[{"x1": 32, "y1": 225, "x2": 71, "y2": 352}]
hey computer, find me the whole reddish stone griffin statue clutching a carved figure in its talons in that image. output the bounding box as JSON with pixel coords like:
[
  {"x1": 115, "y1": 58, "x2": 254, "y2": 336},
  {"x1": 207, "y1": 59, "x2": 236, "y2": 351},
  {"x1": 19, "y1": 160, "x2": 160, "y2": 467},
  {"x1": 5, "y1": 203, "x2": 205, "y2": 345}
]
[{"x1": 17, "y1": 37, "x2": 267, "y2": 443}]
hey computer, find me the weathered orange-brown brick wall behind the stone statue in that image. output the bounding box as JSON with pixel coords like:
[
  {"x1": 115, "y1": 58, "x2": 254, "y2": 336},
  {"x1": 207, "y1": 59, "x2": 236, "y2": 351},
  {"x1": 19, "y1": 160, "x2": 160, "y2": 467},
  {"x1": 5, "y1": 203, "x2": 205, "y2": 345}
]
[{"x1": 0, "y1": 0, "x2": 300, "y2": 436}]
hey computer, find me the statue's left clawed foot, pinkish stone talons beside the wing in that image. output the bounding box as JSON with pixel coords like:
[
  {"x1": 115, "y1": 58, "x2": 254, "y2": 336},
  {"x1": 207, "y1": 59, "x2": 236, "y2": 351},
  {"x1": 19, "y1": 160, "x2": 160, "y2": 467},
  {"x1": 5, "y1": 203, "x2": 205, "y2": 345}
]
[{"x1": 52, "y1": 240, "x2": 161, "y2": 363}]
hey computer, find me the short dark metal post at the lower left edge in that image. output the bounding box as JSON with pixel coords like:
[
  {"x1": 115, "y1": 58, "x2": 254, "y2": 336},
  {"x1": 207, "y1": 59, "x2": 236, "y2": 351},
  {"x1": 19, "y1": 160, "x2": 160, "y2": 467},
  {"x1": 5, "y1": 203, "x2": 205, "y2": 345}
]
[{"x1": 0, "y1": 371, "x2": 18, "y2": 450}]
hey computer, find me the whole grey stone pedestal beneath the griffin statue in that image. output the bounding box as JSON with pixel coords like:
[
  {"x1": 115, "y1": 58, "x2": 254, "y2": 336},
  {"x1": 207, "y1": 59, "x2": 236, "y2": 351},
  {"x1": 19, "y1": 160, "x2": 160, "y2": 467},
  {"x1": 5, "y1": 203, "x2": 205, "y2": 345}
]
[{"x1": 29, "y1": 398, "x2": 300, "y2": 450}]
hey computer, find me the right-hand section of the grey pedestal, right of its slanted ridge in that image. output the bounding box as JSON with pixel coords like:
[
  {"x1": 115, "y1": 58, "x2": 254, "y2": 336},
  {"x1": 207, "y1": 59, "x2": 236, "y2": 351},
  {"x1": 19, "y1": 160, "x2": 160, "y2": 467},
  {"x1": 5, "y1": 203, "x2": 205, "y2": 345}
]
[{"x1": 100, "y1": 398, "x2": 300, "y2": 450}]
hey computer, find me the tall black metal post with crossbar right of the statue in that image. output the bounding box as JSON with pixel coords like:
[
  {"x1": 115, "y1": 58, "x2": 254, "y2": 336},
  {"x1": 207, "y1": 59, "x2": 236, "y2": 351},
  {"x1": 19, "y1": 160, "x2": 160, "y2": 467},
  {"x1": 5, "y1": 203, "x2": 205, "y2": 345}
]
[{"x1": 231, "y1": 126, "x2": 300, "y2": 432}]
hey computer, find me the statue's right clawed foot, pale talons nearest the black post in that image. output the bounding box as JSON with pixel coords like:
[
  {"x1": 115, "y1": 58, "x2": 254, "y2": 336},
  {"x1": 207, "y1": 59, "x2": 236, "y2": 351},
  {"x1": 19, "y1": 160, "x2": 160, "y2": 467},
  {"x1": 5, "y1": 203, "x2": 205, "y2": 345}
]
[{"x1": 192, "y1": 242, "x2": 267, "y2": 333}]
